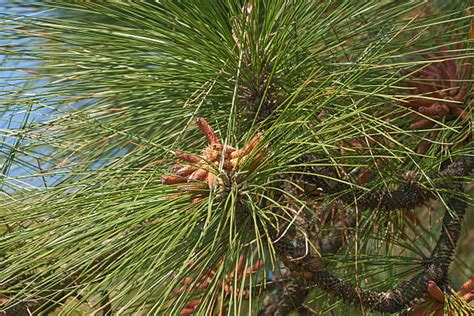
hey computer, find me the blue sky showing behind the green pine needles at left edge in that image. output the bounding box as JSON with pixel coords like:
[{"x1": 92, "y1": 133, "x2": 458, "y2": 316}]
[{"x1": 0, "y1": 0, "x2": 59, "y2": 194}]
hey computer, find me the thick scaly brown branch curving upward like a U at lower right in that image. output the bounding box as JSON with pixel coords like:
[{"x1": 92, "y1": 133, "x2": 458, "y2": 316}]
[{"x1": 277, "y1": 159, "x2": 473, "y2": 313}]
